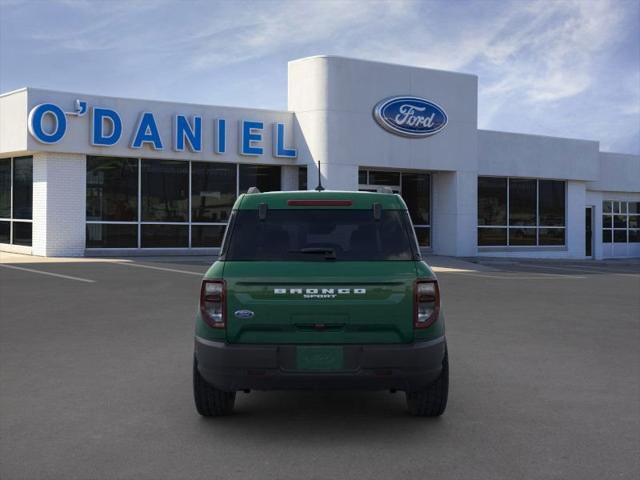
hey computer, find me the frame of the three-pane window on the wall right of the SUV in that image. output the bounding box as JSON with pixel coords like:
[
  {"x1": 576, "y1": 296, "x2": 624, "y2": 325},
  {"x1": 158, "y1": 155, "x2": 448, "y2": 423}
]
[{"x1": 476, "y1": 175, "x2": 568, "y2": 251}]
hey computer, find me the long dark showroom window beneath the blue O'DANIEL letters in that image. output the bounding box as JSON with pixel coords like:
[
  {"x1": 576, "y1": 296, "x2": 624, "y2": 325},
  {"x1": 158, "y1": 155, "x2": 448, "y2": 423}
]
[{"x1": 86, "y1": 157, "x2": 280, "y2": 248}]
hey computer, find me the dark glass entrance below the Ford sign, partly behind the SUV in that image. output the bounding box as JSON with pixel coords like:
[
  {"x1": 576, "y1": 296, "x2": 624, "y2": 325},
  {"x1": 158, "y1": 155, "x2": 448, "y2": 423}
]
[{"x1": 358, "y1": 168, "x2": 431, "y2": 247}]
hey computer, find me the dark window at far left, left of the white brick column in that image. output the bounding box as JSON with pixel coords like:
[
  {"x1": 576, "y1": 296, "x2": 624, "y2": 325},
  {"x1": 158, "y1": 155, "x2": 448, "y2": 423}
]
[{"x1": 0, "y1": 157, "x2": 33, "y2": 247}]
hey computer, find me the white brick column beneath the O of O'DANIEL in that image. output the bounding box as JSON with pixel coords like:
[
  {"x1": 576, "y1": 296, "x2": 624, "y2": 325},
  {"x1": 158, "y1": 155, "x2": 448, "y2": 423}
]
[{"x1": 32, "y1": 152, "x2": 87, "y2": 257}]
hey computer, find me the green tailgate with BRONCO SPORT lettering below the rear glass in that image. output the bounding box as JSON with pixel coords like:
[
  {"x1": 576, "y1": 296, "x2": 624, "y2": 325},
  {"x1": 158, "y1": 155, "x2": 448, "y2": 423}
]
[{"x1": 224, "y1": 261, "x2": 416, "y2": 344}]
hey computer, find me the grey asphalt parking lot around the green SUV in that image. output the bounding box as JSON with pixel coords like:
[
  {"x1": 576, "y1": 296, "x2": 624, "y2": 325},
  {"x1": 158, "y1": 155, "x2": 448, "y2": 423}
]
[{"x1": 0, "y1": 253, "x2": 640, "y2": 480}]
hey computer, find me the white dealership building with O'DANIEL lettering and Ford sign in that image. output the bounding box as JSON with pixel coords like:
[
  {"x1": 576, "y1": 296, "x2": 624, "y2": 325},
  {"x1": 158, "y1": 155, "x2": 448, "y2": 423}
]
[{"x1": 0, "y1": 56, "x2": 640, "y2": 259}]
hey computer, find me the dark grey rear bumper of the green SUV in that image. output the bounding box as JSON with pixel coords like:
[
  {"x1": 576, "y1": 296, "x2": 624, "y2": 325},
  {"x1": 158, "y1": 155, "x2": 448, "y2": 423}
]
[{"x1": 195, "y1": 336, "x2": 446, "y2": 391}]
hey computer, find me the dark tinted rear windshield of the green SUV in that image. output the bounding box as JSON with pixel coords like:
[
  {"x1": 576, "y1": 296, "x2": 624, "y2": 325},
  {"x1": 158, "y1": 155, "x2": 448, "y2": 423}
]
[{"x1": 223, "y1": 209, "x2": 418, "y2": 261}]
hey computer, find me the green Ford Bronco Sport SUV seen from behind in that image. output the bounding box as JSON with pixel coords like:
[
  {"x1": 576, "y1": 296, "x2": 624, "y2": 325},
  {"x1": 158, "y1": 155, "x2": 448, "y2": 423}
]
[{"x1": 193, "y1": 191, "x2": 449, "y2": 416}]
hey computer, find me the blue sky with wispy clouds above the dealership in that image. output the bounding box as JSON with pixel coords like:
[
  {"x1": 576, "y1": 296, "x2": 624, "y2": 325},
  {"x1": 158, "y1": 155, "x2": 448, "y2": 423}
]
[{"x1": 0, "y1": 0, "x2": 640, "y2": 154}]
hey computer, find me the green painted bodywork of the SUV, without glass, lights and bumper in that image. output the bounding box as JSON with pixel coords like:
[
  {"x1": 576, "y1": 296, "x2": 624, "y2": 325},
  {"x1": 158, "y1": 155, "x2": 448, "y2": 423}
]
[{"x1": 196, "y1": 192, "x2": 444, "y2": 345}]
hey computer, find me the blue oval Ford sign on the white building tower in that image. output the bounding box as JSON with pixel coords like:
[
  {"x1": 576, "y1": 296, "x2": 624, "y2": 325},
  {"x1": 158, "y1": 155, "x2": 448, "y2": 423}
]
[{"x1": 373, "y1": 96, "x2": 447, "y2": 138}]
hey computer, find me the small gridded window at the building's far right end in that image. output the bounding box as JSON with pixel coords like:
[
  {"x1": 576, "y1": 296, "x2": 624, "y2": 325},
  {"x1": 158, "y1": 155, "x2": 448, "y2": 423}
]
[{"x1": 602, "y1": 200, "x2": 640, "y2": 243}]
